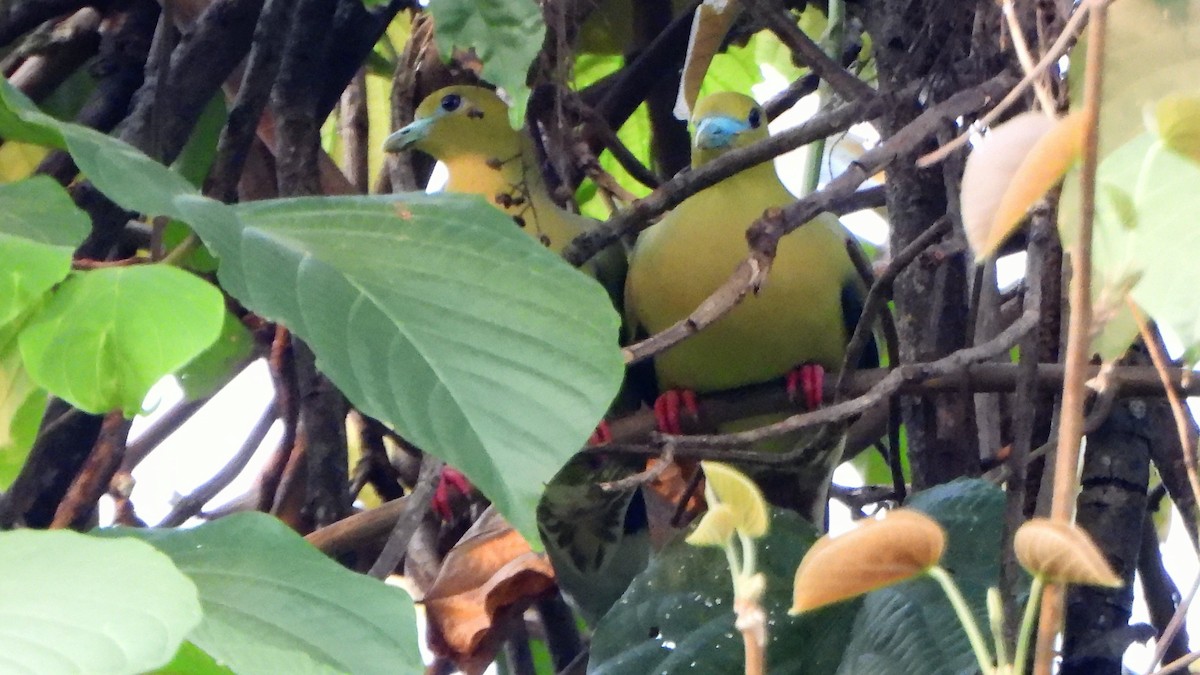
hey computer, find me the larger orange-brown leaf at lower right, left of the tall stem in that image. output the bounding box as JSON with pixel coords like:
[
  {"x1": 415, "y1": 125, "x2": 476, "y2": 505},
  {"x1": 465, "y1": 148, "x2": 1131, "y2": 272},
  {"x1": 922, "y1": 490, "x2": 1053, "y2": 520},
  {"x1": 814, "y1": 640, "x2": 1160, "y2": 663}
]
[{"x1": 788, "y1": 508, "x2": 946, "y2": 614}]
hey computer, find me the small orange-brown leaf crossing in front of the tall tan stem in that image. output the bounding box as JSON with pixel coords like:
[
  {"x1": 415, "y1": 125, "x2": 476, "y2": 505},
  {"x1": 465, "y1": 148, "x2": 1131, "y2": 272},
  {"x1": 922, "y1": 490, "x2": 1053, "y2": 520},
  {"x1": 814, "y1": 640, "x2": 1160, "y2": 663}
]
[{"x1": 1013, "y1": 518, "x2": 1122, "y2": 589}]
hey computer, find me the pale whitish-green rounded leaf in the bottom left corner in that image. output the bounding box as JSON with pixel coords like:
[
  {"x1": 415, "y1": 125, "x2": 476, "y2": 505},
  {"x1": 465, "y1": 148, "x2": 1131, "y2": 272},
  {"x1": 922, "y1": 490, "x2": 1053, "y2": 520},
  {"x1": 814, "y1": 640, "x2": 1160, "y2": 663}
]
[{"x1": 0, "y1": 530, "x2": 200, "y2": 674}]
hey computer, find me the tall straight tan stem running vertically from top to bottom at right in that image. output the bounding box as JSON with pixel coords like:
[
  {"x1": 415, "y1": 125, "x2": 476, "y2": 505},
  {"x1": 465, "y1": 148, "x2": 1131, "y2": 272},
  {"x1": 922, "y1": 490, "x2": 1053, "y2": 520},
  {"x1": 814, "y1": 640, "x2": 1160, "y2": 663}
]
[{"x1": 1033, "y1": 2, "x2": 1108, "y2": 675}]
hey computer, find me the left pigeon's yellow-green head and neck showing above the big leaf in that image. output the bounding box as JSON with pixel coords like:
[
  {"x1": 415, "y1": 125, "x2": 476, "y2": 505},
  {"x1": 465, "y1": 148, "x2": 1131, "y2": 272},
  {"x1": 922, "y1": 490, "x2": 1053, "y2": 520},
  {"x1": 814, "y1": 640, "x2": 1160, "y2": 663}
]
[{"x1": 384, "y1": 85, "x2": 626, "y2": 297}]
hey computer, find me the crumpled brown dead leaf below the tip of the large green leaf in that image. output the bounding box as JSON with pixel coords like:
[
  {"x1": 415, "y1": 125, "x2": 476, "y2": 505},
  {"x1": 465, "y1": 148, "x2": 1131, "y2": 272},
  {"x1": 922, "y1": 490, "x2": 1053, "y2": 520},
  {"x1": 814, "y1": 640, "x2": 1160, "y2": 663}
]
[{"x1": 424, "y1": 508, "x2": 554, "y2": 674}]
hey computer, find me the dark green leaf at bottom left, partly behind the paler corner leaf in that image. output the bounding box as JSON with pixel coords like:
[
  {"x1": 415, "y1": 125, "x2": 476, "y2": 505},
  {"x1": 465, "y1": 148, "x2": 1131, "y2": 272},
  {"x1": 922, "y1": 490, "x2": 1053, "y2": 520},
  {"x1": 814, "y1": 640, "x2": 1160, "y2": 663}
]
[{"x1": 102, "y1": 513, "x2": 422, "y2": 675}]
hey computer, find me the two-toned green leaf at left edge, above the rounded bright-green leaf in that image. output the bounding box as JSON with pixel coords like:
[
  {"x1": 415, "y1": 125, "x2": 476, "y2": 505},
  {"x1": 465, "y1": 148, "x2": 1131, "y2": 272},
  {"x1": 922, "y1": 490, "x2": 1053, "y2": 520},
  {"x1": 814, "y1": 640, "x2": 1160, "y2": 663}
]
[{"x1": 0, "y1": 177, "x2": 90, "y2": 325}]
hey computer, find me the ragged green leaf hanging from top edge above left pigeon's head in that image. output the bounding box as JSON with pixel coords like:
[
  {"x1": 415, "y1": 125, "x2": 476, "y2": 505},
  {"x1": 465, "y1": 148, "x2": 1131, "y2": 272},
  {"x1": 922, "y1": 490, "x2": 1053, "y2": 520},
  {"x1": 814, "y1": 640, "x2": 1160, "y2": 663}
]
[{"x1": 430, "y1": 0, "x2": 546, "y2": 127}]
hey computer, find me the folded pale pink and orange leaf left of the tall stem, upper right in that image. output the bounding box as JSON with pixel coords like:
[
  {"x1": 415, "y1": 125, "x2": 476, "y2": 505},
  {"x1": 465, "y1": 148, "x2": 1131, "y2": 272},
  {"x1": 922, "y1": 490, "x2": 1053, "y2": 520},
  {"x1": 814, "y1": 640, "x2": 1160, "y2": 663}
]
[{"x1": 962, "y1": 112, "x2": 1084, "y2": 259}]
